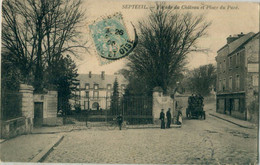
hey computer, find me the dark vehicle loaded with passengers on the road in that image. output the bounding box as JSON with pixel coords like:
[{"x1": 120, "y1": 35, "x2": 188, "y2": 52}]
[{"x1": 186, "y1": 95, "x2": 206, "y2": 120}]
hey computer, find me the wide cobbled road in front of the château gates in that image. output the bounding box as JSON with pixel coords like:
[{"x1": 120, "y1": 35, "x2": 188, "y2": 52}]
[{"x1": 44, "y1": 108, "x2": 257, "y2": 164}]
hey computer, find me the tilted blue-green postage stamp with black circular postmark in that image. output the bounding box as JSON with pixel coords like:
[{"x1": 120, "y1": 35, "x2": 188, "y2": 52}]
[{"x1": 89, "y1": 13, "x2": 137, "y2": 60}]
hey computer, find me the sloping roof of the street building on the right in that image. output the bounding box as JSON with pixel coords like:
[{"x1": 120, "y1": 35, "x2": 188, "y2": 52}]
[{"x1": 217, "y1": 32, "x2": 255, "y2": 54}]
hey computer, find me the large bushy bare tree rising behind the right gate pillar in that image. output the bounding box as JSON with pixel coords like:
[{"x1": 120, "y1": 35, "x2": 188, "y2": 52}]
[{"x1": 125, "y1": 3, "x2": 210, "y2": 94}]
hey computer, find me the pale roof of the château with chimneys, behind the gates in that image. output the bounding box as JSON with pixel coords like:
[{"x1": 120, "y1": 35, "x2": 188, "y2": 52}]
[{"x1": 77, "y1": 74, "x2": 128, "y2": 88}]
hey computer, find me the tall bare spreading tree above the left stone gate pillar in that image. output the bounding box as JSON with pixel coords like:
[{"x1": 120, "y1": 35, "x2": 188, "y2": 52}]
[{"x1": 2, "y1": 0, "x2": 85, "y2": 92}]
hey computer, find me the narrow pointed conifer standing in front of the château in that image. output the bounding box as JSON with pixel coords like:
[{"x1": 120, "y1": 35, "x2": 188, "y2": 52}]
[{"x1": 111, "y1": 78, "x2": 119, "y2": 115}]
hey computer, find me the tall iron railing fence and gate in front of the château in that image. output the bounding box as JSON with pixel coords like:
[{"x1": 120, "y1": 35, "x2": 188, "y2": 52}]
[{"x1": 73, "y1": 96, "x2": 153, "y2": 124}]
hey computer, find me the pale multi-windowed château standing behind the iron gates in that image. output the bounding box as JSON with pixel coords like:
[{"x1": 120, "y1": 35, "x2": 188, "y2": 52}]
[{"x1": 74, "y1": 71, "x2": 127, "y2": 110}]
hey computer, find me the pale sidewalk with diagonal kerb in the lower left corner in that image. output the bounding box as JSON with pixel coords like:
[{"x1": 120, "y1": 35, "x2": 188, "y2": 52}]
[{"x1": 0, "y1": 134, "x2": 63, "y2": 162}]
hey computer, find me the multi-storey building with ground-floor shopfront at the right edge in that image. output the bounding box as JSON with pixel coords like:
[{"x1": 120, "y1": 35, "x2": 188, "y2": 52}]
[{"x1": 216, "y1": 32, "x2": 259, "y2": 120}]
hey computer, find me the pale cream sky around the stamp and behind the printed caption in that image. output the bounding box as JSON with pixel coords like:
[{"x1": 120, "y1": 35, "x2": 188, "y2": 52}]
[{"x1": 76, "y1": 0, "x2": 259, "y2": 74}]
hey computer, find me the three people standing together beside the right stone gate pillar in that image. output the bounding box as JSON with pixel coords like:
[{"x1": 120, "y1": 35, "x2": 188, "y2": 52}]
[{"x1": 159, "y1": 108, "x2": 182, "y2": 129}]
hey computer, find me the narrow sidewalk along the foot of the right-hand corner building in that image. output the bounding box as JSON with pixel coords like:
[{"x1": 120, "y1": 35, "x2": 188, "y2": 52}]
[{"x1": 208, "y1": 110, "x2": 257, "y2": 129}]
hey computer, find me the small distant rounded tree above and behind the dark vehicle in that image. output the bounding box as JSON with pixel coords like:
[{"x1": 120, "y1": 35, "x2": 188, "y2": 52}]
[{"x1": 188, "y1": 64, "x2": 217, "y2": 96}]
